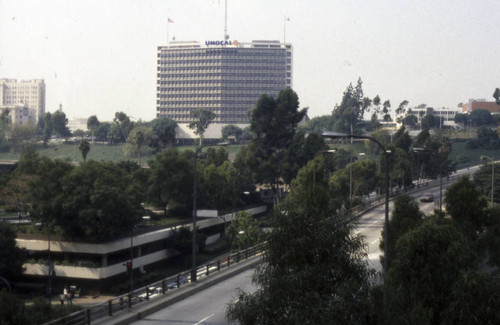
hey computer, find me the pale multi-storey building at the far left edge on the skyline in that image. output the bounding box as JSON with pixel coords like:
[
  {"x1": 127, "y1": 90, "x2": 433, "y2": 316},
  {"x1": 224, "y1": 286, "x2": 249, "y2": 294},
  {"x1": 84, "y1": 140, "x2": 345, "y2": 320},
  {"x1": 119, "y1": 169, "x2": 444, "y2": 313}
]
[{"x1": 0, "y1": 79, "x2": 45, "y2": 124}]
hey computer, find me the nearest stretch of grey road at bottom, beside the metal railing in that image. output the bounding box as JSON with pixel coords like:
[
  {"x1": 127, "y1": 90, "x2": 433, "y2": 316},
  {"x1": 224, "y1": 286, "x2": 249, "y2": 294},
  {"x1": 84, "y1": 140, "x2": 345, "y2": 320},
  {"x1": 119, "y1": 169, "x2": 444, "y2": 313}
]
[{"x1": 132, "y1": 269, "x2": 256, "y2": 325}]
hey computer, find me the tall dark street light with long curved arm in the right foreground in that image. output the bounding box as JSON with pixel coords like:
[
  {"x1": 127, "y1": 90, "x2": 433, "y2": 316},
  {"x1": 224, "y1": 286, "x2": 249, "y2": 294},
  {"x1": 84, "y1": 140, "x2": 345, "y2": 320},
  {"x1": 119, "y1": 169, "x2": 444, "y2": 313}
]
[{"x1": 322, "y1": 132, "x2": 389, "y2": 311}]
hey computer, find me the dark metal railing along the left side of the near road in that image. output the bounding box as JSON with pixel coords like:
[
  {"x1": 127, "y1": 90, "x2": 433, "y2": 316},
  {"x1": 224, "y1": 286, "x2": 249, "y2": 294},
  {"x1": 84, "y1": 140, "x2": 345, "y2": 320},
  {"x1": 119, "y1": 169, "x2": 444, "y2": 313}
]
[{"x1": 45, "y1": 243, "x2": 266, "y2": 325}]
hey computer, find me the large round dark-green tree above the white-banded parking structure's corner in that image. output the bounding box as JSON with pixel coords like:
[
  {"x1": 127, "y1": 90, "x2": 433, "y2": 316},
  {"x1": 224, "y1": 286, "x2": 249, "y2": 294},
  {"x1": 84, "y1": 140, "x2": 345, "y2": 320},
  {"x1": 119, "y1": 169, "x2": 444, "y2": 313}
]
[{"x1": 57, "y1": 160, "x2": 141, "y2": 241}]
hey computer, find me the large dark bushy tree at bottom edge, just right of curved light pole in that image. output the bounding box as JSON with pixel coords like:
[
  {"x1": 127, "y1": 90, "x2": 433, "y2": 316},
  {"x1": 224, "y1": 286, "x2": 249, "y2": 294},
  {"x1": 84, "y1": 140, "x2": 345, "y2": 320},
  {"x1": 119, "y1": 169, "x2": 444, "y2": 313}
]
[{"x1": 384, "y1": 217, "x2": 475, "y2": 324}]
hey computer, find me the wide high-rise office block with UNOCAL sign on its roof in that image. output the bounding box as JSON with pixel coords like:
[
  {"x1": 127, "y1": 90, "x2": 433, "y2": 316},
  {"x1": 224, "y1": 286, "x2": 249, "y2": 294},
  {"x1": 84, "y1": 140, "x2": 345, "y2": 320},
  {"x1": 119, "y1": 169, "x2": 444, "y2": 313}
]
[{"x1": 156, "y1": 41, "x2": 293, "y2": 125}]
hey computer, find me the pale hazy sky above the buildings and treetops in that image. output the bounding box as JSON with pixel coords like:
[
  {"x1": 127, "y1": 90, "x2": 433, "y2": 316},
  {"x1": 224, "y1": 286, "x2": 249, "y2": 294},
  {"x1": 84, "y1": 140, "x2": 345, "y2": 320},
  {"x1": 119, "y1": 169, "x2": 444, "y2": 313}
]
[{"x1": 0, "y1": 0, "x2": 500, "y2": 121}]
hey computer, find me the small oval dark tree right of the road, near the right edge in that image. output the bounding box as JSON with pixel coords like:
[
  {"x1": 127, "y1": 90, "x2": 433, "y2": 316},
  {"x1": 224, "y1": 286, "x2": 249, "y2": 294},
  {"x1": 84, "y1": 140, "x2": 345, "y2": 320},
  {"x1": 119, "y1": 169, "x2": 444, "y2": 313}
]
[{"x1": 444, "y1": 177, "x2": 488, "y2": 237}]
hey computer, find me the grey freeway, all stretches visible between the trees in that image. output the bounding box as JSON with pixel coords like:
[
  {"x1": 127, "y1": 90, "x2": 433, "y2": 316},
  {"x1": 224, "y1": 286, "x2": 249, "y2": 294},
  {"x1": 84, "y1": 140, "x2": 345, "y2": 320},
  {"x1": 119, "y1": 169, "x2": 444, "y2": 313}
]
[{"x1": 127, "y1": 168, "x2": 477, "y2": 325}]
